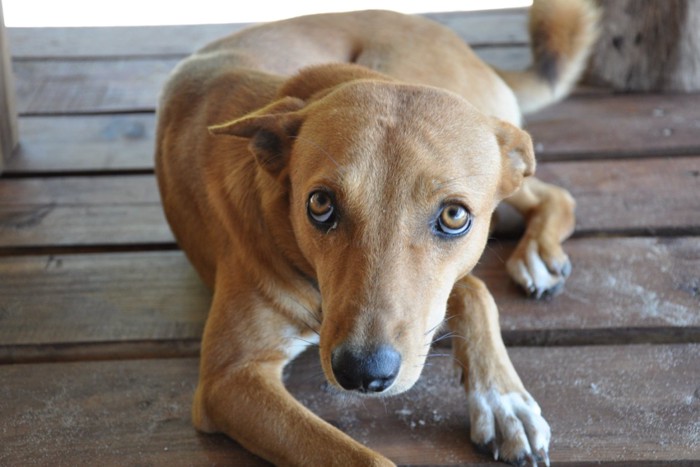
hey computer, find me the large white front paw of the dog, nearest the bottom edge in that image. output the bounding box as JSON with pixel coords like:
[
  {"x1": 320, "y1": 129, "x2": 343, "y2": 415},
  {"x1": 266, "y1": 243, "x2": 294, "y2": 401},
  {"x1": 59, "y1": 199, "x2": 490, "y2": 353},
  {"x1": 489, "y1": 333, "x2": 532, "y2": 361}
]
[{"x1": 469, "y1": 389, "x2": 551, "y2": 466}]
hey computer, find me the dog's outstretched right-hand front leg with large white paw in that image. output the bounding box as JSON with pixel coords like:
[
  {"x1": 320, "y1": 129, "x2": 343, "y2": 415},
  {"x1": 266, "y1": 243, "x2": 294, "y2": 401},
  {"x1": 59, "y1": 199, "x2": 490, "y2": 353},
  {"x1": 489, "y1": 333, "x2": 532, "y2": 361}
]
[{"x1": 447, "y1": 276, "x2": 550, "y2": 464}]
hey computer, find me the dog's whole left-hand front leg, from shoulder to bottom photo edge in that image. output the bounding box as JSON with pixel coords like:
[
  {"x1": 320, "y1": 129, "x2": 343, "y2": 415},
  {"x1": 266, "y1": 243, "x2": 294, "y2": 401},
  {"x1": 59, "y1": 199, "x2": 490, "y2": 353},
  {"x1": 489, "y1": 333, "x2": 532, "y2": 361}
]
[{"x1": 192, "y1": 274, "x2": 394, "y2": 466}]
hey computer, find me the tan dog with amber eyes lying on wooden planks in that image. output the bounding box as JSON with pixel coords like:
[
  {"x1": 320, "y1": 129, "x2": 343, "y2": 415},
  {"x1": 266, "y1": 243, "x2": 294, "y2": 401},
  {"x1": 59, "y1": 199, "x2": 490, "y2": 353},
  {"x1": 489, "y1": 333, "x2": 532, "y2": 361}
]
[{"x1": 156, "y1": 0, "x2": 597, "y2": 466}]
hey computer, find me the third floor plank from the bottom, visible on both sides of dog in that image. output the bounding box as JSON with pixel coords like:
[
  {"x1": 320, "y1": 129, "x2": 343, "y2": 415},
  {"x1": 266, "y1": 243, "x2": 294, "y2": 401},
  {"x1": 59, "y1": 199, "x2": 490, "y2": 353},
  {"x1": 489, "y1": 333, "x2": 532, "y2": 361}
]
[{"x1": 0, "y1": 157, "x2": 700, "y2": 248}]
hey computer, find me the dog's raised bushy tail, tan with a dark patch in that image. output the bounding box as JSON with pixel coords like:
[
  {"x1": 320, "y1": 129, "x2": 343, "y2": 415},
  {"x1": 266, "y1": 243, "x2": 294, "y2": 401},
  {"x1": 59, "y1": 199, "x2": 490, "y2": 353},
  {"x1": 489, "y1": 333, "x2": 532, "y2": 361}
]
[{"x1": 496, "y1": 0, "x2": 600, "y2": 113}]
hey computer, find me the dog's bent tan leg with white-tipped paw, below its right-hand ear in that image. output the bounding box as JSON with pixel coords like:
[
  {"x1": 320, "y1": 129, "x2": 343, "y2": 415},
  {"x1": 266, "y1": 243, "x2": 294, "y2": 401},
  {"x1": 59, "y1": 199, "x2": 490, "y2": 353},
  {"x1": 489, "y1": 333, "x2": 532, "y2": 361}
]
[{"x1": 505, "y1": 177, "x2": 576, "y2": 298}]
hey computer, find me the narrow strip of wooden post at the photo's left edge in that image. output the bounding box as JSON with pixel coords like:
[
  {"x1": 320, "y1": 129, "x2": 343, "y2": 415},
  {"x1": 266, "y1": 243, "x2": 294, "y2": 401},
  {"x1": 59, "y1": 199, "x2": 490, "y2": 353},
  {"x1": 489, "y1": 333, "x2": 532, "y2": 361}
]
[{"x1": 0, "y1": 0, "x2": 18, "y2": 173}]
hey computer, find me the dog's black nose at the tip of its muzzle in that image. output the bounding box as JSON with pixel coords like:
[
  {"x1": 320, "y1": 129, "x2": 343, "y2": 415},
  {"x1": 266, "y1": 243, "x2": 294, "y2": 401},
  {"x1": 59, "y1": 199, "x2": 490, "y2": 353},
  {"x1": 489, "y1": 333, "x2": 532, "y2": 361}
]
[{"x1": 331, "y1": 345, "x2": 401, "y2": 392}]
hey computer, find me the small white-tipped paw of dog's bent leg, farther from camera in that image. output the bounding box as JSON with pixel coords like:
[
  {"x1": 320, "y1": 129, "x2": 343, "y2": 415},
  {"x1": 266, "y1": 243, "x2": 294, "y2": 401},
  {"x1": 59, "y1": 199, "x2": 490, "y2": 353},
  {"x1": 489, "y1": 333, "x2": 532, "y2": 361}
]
[{"x1": 506, "y1": 238, "x2": 571, "y2": 299}]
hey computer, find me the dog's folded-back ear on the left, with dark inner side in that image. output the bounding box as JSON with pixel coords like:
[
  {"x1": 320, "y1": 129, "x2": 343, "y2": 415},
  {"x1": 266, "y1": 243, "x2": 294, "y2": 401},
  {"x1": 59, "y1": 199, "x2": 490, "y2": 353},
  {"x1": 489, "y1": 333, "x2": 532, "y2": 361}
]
[{"x1": 209, "y1": 97, "x2": 305, "y2": 174}]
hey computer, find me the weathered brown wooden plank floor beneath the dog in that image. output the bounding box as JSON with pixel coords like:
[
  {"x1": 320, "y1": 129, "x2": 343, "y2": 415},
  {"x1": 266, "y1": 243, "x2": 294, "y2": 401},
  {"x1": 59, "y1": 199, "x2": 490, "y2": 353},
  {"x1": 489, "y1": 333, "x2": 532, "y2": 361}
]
[{"x1": 0, "y1": 11, "x2": 700, "y2": 466}]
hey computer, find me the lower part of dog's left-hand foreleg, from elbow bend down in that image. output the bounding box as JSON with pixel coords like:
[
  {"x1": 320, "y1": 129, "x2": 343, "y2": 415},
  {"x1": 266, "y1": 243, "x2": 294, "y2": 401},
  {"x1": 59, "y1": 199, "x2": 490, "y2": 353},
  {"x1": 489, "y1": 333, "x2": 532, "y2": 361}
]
[{"x1": 194, "y1": 361, "x2": 394, "y2": 466}]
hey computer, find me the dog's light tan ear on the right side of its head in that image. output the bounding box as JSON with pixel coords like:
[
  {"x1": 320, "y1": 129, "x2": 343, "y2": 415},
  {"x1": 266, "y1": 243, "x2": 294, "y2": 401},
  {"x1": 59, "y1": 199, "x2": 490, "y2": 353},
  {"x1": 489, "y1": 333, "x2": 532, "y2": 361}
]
[{"x1": 494, "y1": 119, "x2": 535, "y2": 199}]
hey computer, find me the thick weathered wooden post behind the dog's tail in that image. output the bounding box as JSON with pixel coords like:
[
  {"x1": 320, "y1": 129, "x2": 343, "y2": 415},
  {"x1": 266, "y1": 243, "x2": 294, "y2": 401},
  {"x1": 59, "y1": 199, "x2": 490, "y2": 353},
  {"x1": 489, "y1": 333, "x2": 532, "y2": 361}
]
[{"x1": 586, "y1": 0, "x2": 700, "y2": 92}]
